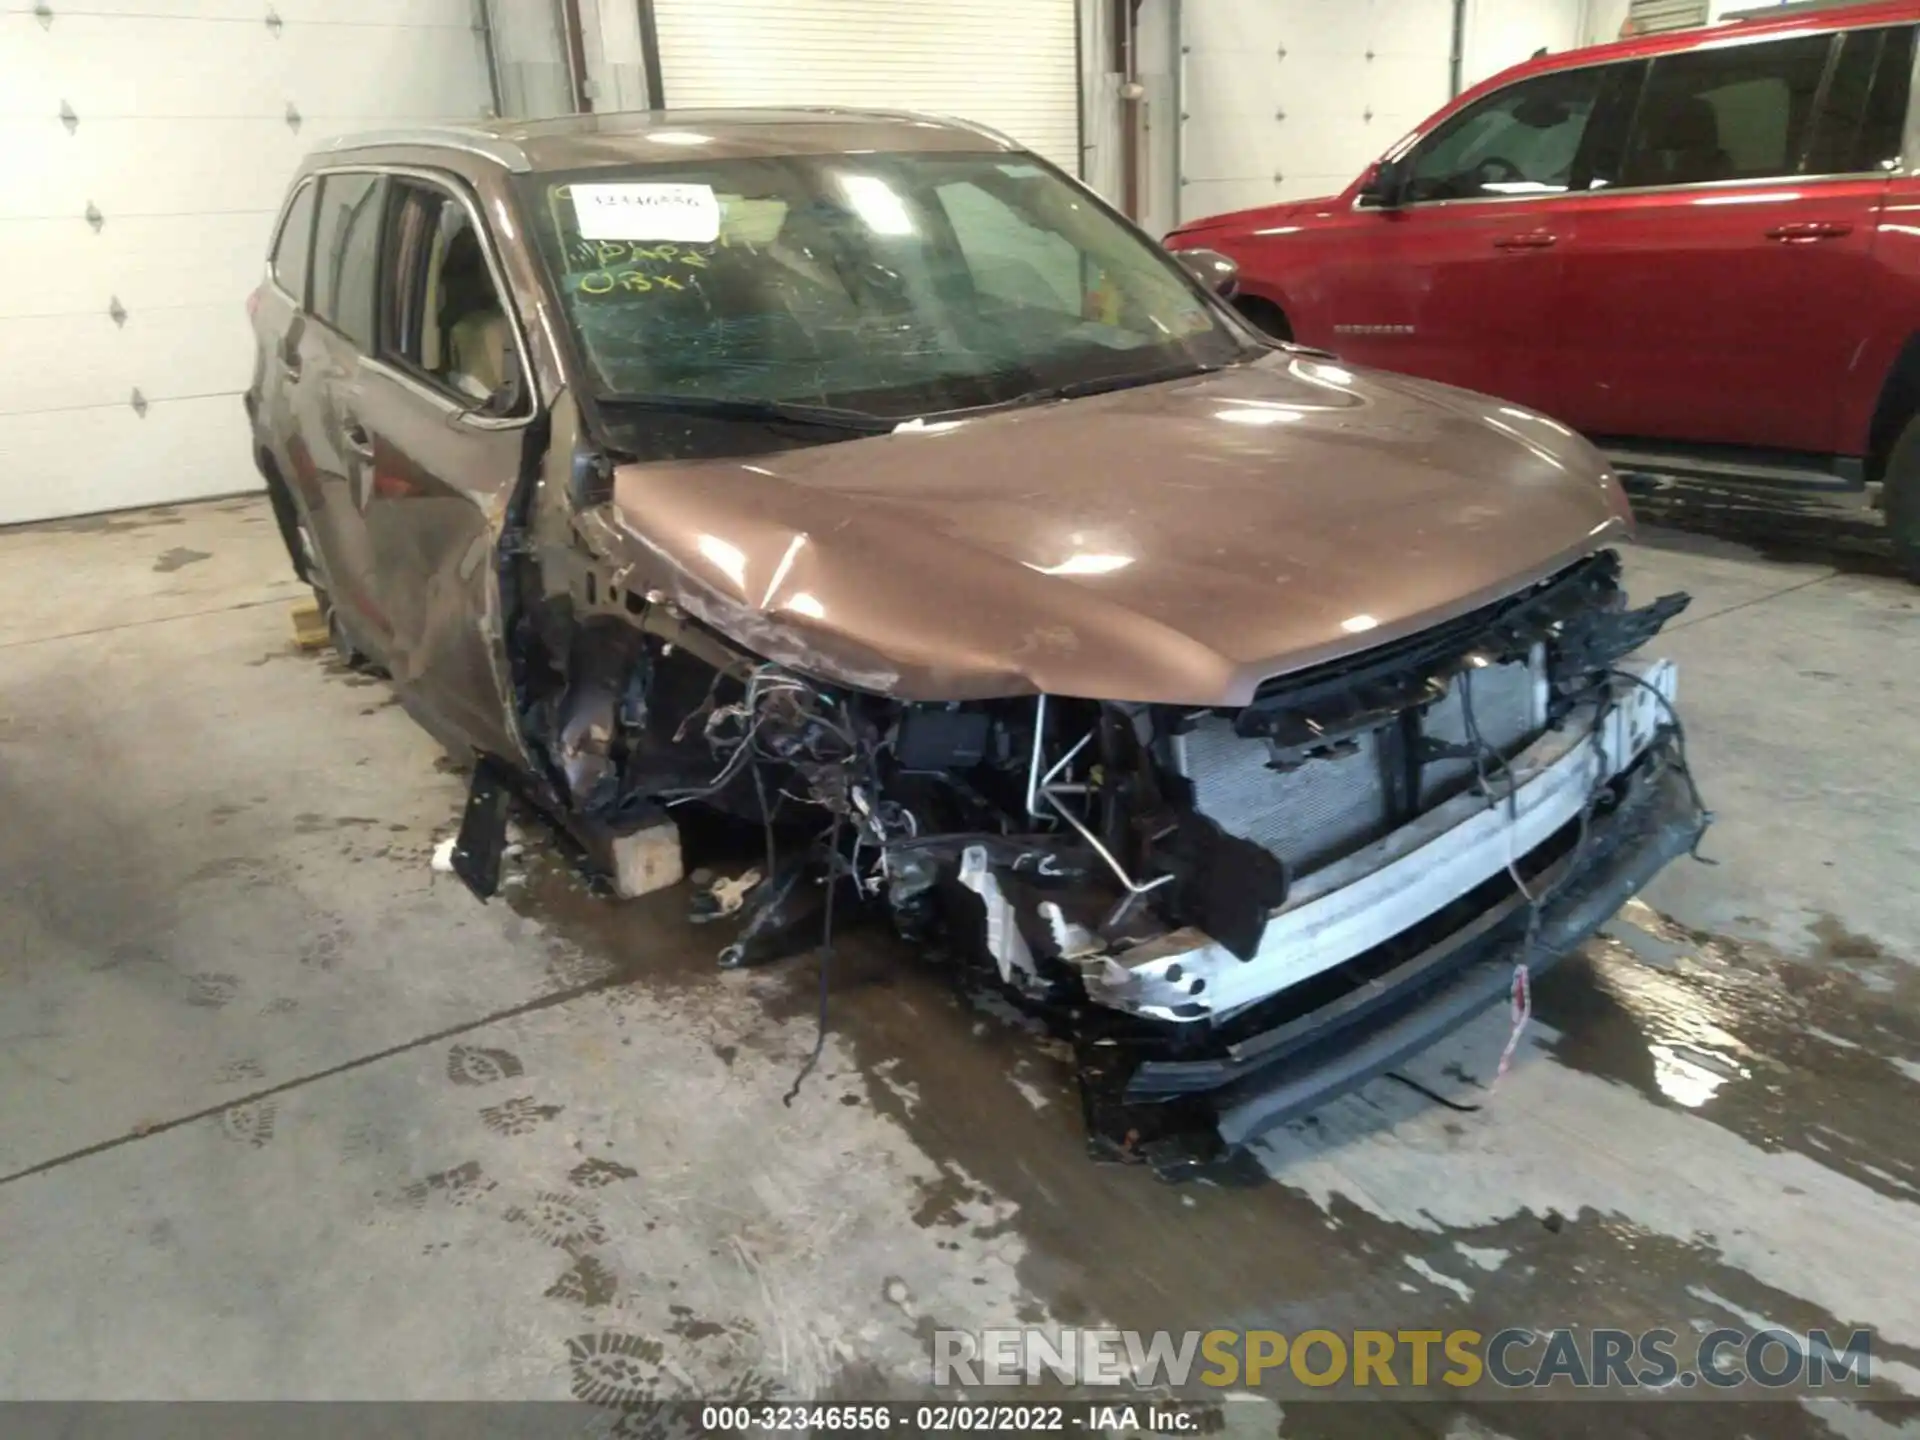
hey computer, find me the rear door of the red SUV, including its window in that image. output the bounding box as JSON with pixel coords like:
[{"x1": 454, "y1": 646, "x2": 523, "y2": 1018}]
[{"x1": 1553, "y1": 27, "x2": 1912, "y2": 453}]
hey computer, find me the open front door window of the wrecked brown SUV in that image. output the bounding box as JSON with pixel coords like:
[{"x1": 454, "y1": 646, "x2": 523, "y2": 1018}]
[{"x1": 380, "y1": 180, "x2": 520, "y2": 415}]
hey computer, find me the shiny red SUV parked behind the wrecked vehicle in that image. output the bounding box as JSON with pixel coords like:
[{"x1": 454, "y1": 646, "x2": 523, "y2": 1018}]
[{"x1": 1167, "y1": 0, "x2": 1920, "y2": 570}]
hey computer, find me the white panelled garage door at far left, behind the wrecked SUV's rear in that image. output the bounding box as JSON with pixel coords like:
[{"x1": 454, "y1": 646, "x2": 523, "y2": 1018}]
[{"x1": 0, "y1": 0, "x2": 488, "y2": 522}]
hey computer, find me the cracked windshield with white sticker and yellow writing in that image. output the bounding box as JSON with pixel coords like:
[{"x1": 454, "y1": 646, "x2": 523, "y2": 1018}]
[{"x1": 522, "y1": 152, "x2": 1246, "y2": 419}]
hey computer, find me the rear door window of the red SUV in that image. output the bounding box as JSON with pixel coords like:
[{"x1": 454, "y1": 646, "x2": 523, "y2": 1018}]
[{"x1": 1620, "y1": 35, "x2": 1836, "y2": 186}]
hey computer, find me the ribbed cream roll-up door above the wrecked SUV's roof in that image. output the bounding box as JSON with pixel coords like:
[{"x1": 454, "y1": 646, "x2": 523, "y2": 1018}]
[{"x1": 655, "y1": 0, "x2": 1079, "y2": 175}]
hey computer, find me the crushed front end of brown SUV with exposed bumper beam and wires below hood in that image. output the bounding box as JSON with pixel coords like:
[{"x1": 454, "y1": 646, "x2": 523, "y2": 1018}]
[{"x1": 526, "y1": 551, "x2": 1707, "y2": 1173}]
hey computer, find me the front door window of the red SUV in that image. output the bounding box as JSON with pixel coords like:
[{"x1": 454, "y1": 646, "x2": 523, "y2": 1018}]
[{"x1": 1407, "y1": 69, "x2": 1601, "y2": 202}]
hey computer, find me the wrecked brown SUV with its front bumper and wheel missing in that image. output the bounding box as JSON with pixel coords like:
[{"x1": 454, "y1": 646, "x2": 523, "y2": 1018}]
[{"x1": 248, "y1": 111, "x2": 1707, "y2": 1171}]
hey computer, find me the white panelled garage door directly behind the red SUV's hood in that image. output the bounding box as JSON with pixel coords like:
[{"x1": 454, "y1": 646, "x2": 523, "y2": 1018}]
[{"x1": 1179, "y1": 0, "x2": 1453, "y2": 219}]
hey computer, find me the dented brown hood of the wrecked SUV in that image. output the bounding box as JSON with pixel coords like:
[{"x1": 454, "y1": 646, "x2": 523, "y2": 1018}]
[{"x1": 609, "y1": 353, "x2": 1630, "y2": 705}]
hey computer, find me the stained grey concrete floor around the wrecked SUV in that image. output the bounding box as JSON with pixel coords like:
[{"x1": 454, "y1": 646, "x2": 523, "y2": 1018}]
[{"x1": 0, "y1": 499, "x2": 1920, "y2": 1436}]
